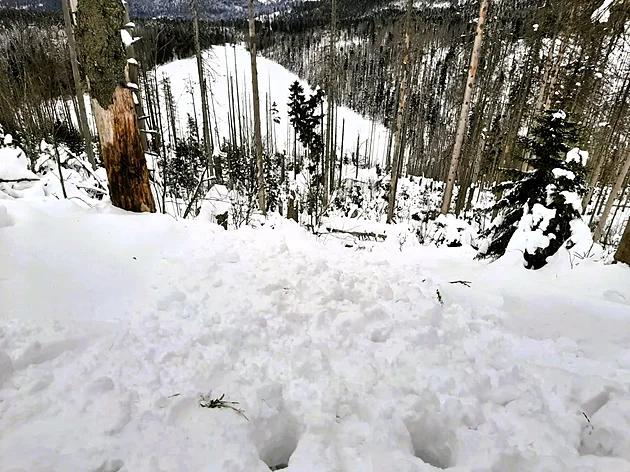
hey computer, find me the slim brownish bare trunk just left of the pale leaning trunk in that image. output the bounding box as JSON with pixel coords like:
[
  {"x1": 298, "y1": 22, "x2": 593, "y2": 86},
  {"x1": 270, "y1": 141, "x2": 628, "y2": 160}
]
[{"x1": 387, "y1": 0, "x2": 413, "y2": 224}]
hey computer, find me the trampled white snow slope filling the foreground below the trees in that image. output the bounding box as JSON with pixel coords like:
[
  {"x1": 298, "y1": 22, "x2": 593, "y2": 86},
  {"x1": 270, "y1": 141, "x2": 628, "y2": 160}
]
[{"x1": 0, "y1": 199, "x2": 630, "y2": 472}]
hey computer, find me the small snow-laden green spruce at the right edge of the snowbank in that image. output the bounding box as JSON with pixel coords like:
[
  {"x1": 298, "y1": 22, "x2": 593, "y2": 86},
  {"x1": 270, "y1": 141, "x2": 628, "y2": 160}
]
[{"x1": 478, "y1": 111, "x2": 588, "y2": 269}]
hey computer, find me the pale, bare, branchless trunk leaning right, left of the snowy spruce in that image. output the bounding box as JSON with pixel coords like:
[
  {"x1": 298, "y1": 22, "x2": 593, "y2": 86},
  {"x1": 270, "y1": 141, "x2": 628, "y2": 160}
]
[{"x1": 442, "y1": 0, "x2": 489, "y2": 215}]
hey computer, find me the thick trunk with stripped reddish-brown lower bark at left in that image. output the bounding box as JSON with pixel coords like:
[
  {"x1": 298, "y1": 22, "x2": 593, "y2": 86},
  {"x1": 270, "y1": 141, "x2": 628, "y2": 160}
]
[{"x1": 76, "y1": 0, "x2": 155, "y2": 212}]
